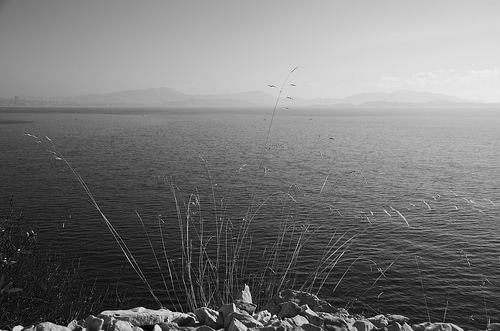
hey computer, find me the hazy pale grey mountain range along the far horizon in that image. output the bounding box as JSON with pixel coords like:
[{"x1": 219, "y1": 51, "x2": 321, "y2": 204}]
[{"x1": 17, "y1": 88, "x2": 486, "y2": 108}]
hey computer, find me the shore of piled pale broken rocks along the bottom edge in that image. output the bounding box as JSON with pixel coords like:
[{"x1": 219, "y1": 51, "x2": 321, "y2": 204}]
[{"x1": 0, "y1": 286, "x2": 500, "y2": 331}]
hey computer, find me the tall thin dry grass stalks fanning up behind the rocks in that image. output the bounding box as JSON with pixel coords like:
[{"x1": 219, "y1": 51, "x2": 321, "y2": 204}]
[{"x1": 38, "y1": 67, "x2": 392, "y2": 311}]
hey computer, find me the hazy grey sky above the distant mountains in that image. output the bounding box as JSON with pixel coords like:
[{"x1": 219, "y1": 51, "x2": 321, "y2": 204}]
[{"x1": 0, "y1": 0, "x2": 500, "y2": 102}]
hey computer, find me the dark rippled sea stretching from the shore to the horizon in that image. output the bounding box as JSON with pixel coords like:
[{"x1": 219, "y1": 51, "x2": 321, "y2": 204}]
[{"x1": 0, "y1": 107, "x2": 500, "y2": 328}]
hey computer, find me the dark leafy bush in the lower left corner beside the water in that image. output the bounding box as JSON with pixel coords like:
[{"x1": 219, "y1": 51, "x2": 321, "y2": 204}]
[{"x1": 0, "y1": 200, "x2": 124, "y2": 329}]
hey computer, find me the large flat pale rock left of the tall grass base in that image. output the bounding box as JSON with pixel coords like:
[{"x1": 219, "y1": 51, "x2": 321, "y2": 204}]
[{"x1": 97, "y1": 307, "x2": 172, "y2": 330}]
